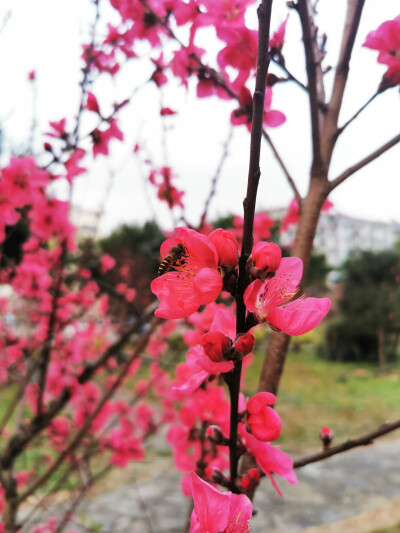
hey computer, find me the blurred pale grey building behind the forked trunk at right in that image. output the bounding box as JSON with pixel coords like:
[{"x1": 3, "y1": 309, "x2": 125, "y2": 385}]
[{"x1": 271, "y1": 210, "x2": 400, "y2": 267}]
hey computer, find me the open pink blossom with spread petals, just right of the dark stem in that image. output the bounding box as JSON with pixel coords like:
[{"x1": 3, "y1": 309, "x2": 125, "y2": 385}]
[{"x1": 244, "y1": 257, "x2": 331, "y2": 335}]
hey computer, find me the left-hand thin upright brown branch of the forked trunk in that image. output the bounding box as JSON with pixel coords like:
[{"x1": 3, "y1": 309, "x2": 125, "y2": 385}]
[{"x1": 295, "y1": 0, "x2": 325, "y2": 175}]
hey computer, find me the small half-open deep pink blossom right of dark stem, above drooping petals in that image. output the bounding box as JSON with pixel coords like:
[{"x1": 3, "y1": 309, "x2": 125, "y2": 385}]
[{"x1": 246, "y1": 392, "x2": 282, "y2": 441}]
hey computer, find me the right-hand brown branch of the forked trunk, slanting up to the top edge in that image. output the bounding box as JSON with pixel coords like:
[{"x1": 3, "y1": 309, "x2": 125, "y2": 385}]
[{"x1": 322, "y1": 0, "x2": 365, "y2": 163}]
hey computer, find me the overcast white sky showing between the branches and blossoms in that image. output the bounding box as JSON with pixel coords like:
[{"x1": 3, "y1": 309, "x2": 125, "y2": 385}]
[{"x1": 0, "y1": 0, "x2": 400, "y2": 232}]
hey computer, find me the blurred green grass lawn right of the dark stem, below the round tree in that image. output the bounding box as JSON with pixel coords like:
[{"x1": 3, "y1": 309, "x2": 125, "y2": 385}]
[{"x1": 246, "y1": 330, "x2": 400, "y2": 450}]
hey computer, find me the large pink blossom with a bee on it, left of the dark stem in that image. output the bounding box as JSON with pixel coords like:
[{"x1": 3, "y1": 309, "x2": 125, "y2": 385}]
[{"x1": 151, "y1": 228, "x2": 222, "y2": 318}]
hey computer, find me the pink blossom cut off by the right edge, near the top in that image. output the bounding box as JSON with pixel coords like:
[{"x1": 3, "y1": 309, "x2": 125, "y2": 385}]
[{"x1": 363, "y1": 15, "x2": 400, "y2": 86}]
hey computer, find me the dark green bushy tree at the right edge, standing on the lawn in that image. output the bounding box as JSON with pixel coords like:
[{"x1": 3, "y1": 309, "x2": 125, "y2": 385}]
[{"x1": 327, "y1": 250, "x2": 400, "y2": 372}]
